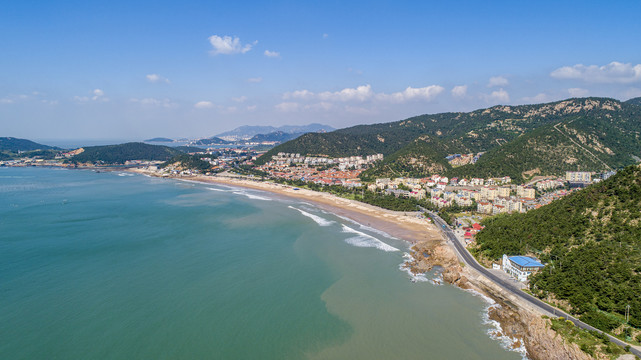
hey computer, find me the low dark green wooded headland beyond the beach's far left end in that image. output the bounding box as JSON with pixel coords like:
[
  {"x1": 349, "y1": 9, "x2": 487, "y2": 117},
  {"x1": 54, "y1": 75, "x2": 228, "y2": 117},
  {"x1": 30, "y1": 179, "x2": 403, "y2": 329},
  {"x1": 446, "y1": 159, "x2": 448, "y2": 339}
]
[{"x1": 70, "y1": 143, "x2": 182, "y2": 164}]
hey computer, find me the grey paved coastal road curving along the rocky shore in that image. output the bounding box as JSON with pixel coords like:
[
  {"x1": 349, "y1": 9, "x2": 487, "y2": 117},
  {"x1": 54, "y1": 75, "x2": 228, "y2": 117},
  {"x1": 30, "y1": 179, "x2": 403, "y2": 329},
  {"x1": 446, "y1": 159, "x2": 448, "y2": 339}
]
[{"x1": 427, "y1": 211, "x2": 641, "y2": 357}]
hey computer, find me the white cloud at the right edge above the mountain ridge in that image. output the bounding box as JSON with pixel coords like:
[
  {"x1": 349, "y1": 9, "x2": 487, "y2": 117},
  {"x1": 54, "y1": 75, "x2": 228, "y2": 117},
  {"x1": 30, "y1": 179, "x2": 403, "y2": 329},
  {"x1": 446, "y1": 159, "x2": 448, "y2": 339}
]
[{"x1": 550, "y1": 61, "x2": 641, "y2": 84}]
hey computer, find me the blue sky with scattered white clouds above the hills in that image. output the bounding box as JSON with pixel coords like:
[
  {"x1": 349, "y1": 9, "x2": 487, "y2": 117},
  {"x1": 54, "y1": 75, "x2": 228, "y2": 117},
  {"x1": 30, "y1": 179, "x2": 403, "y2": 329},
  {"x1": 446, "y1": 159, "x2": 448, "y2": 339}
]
[{"x1": 0, "y1": 1, "x2": 641, "y2": 140}]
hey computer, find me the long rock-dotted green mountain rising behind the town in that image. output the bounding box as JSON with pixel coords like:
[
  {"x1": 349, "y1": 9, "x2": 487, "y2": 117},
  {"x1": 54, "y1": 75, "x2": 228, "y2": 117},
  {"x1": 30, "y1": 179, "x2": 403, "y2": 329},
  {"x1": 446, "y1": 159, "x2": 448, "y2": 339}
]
[{"x1": 257, "y1": 98, "x2": 641, "y2": 180}]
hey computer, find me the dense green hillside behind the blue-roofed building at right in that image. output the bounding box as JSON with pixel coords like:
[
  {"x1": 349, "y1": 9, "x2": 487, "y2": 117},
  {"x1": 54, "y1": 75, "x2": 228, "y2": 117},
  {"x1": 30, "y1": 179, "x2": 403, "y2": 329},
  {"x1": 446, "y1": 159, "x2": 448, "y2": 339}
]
[{"x1": 475, "y1": 165, "x2": 641, "y2": 330}]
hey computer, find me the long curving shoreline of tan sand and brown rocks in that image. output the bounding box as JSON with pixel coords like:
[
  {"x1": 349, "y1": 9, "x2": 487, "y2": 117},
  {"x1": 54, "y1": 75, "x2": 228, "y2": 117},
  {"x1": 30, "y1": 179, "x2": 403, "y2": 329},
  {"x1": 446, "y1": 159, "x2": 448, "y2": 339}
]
[{"x1": 125, "y1": 168, "x2": 591, "y2": 360}]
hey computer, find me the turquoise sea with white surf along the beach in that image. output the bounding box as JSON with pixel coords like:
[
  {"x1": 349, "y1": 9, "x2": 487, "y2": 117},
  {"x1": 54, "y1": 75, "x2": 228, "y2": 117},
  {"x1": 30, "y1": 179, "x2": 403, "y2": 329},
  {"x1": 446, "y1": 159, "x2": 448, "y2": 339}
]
[{"x1": 0, "y1": 167, "x2": 524, "y2": 360}]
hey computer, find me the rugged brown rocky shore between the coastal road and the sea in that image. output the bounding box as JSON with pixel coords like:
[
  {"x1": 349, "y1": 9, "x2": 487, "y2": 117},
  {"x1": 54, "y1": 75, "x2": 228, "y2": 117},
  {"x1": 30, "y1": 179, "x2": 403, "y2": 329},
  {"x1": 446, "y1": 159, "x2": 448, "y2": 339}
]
[{"x1": 408, "y1": 241, "x2": 592, "y2": 360}]
